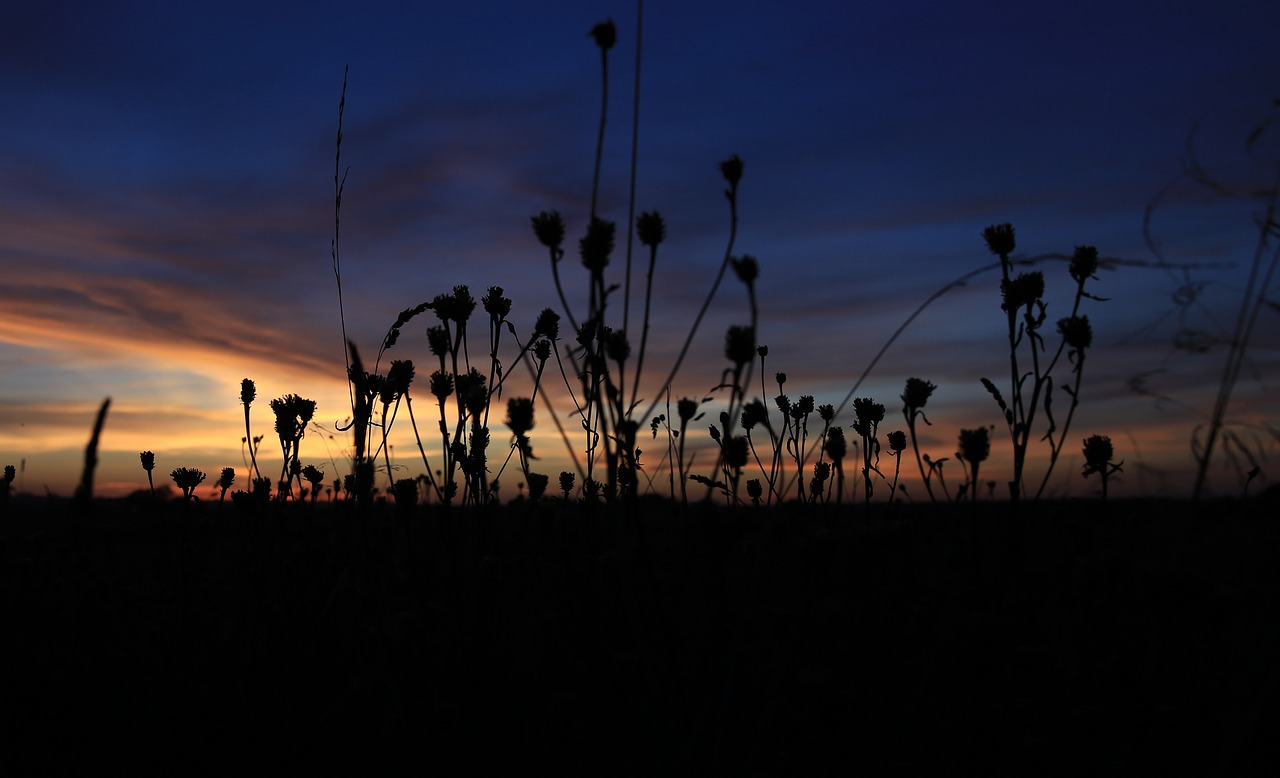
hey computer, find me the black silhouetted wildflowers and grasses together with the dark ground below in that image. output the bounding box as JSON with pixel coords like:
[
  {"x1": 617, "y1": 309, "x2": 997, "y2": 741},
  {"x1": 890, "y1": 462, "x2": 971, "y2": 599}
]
[{"x1": 0, "y1": 9, "x2": 1280, "y2": 775}]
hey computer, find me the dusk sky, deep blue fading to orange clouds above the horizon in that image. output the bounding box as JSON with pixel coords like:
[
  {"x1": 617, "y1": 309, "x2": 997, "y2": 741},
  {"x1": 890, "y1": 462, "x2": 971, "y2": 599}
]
[{"x1": 0, "y1": 0, "x2": 1280, "y2": 496}]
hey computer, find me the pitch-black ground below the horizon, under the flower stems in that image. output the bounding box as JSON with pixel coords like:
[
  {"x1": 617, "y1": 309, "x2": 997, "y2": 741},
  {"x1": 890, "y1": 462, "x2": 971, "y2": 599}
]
[{"x1": 0, "y1": 499, "x2": 1280, "y2": 777}]
